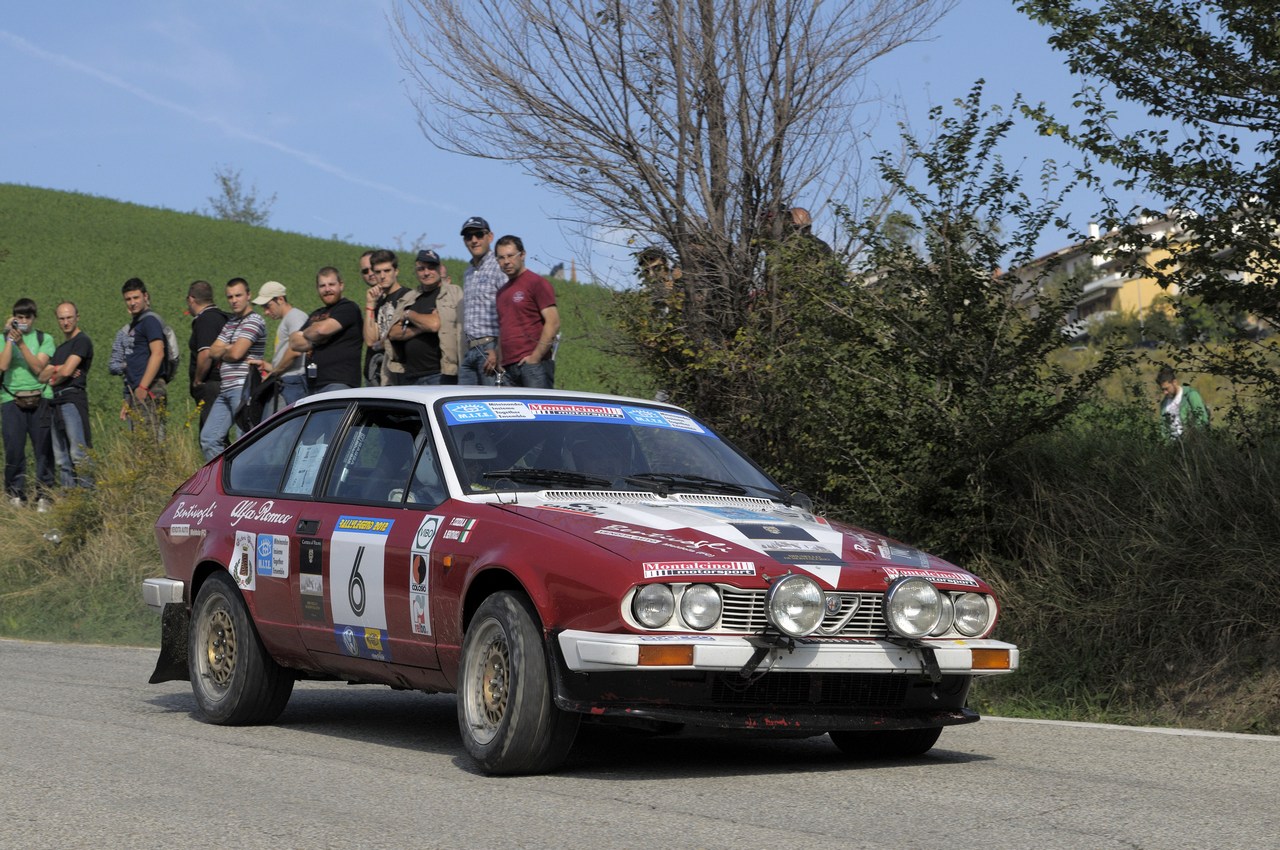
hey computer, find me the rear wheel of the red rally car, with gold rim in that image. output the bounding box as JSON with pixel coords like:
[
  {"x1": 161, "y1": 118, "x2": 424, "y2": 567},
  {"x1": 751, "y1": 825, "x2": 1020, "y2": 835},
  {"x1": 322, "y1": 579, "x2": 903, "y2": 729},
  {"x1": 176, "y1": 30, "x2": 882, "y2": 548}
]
[{"x1": 187, "y1": 572, "x2": 294, "y2": 726}]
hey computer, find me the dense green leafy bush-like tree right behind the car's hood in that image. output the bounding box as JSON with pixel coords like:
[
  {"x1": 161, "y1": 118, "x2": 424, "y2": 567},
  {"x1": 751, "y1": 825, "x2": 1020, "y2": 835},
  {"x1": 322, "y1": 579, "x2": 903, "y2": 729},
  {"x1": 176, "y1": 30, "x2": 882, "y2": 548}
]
[{"x1": 623, "y1": 87, "x2": 1125, "y2": 557}]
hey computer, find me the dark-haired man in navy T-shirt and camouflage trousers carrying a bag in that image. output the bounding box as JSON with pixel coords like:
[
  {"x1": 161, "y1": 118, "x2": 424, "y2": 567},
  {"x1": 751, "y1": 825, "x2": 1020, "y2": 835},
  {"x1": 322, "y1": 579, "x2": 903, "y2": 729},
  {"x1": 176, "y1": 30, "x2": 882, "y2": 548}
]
[{"x1": 109, "y1": 278, "x2": 168, "y2": 439}]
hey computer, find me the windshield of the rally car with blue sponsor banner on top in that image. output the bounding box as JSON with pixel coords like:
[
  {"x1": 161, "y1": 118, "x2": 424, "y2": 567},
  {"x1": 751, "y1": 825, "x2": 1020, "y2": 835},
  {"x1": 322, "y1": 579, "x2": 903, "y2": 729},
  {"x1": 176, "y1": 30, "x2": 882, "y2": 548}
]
[{"x1": 440, "y1": 396, "x2": 783, "y2": 498}]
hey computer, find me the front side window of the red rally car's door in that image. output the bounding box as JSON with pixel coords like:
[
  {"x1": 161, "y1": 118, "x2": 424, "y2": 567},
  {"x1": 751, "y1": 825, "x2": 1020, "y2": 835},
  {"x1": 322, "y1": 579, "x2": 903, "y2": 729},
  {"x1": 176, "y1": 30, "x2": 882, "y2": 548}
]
[{"x1": 325, "y1": 407, "x2": 425, "y2": 504}]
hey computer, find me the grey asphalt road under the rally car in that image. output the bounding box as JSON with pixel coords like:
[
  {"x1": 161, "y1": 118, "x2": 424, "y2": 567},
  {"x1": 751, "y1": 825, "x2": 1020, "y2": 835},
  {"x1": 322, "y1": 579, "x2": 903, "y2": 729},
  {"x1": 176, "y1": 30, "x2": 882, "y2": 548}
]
[{"x1": 0, "y1": 640, "x2": 1280, "y2": 850}]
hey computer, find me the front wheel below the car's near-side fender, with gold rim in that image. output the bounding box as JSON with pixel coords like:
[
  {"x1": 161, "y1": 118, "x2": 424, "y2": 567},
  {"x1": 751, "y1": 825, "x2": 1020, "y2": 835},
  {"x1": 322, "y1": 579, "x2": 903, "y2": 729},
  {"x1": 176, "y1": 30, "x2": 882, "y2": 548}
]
[{"x1": 458, "y1": 591, "x2": 579, "y2": 774}]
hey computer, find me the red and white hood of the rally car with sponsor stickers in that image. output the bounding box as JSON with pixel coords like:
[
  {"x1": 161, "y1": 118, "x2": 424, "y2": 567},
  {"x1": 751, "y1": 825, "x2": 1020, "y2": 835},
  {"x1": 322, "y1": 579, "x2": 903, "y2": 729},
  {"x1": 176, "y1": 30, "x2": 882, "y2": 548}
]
[{"x1": 486, "y1": 490, "x2": 986, "y2": 589}]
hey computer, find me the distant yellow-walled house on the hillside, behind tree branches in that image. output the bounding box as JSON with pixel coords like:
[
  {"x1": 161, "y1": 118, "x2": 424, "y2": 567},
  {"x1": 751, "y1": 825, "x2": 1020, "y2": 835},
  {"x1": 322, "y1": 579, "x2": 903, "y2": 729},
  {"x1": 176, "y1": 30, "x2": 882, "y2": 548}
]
[{"x1": 1009, "y1": 216, "x2": 1179, "y2": 338}]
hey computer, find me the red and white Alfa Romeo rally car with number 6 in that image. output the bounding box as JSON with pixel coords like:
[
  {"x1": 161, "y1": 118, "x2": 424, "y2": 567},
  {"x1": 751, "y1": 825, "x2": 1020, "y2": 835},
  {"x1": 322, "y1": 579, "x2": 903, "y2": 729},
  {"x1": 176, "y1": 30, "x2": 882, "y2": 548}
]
[{"x1": 142, "y1": 387, "x2": 1018, "y2": 773}]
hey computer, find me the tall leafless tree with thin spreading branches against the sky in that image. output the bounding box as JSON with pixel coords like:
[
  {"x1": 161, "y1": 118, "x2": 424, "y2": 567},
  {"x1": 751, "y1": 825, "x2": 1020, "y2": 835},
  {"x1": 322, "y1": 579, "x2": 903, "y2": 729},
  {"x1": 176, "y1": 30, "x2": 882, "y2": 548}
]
[{"x1": 396, "y1": 0, "x2": 955, "y2": 407}]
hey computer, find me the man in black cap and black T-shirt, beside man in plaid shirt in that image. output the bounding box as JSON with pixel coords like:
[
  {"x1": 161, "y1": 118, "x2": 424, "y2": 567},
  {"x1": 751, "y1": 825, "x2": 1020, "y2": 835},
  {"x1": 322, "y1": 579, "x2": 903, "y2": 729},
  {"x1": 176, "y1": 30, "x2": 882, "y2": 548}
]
[{"x1": 387, "y1": 251, "x2": 462, "y2": 385}]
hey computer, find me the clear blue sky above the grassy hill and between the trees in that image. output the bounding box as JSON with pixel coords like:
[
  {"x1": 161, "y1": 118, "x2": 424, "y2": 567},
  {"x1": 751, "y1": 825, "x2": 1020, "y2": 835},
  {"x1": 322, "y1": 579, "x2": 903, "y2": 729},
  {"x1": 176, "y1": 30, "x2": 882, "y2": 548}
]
[{"x1": 0, "y1": 0, "x2": 1088, "y2": 286}]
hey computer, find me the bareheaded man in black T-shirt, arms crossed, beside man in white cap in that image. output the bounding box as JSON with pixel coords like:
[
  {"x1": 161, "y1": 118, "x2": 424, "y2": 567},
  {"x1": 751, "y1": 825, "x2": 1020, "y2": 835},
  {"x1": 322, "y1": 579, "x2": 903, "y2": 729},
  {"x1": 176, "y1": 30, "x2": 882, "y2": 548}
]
[{"x1": 289, "y1": 266, "x2": 364, "y2": 393}]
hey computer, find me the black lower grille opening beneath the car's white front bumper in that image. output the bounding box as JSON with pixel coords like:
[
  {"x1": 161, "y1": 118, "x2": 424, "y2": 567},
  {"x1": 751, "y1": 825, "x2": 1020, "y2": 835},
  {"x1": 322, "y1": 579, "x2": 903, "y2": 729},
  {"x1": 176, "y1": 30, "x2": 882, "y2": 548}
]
[{"x1": 712, "y1": 672, "x2": 910, "y2": 708}]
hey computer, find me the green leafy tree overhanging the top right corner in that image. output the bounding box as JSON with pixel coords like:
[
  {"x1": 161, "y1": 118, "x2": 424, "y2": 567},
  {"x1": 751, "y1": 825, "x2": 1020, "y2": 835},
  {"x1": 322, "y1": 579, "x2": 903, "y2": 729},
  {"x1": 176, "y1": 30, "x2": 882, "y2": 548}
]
[{"x1": 1018, "y1": 0, "x2": 1280, "y2": 406}]
